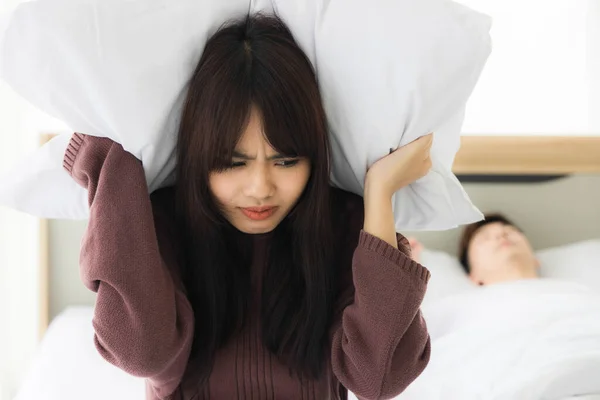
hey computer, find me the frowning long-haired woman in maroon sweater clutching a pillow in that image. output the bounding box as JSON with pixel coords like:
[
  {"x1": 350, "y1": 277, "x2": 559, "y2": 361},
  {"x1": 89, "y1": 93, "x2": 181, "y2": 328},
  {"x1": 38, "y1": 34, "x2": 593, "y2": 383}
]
[{"x1": 65, "y1": 15, "x2": 431, "y2": 400}]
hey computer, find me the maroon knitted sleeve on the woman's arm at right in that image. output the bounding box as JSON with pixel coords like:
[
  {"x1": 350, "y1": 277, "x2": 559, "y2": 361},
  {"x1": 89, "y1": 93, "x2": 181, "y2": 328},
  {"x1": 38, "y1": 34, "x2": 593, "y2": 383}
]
[{"x1": 331, "y1": 191, "x2": 431, "y2": 400}]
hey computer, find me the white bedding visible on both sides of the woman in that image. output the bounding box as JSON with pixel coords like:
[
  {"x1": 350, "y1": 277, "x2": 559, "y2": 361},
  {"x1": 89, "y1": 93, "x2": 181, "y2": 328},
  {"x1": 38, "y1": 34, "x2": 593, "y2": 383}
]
[{"x1": 14, "y1": 279, "x2": 600, "y2": 400}]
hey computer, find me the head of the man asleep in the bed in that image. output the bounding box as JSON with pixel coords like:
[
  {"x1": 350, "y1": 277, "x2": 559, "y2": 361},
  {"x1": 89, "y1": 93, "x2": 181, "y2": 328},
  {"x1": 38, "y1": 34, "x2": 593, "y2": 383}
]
[{"x1": 459, "y1": 214, "x2": 539, "y2": 285}]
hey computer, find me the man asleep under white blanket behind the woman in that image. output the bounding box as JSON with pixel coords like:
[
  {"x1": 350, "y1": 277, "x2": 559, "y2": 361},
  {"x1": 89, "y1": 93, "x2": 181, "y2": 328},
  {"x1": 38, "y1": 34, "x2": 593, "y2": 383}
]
[{"x1": 396, "y1": 214, "x2": 600, "y2": 400}]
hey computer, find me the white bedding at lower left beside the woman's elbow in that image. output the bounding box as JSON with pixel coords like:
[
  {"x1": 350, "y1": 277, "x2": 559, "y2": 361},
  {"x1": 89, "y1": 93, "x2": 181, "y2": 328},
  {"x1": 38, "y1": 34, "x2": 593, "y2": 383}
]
[{"x1": 14, "y1": 307, "x2": 145, "y2": 400}]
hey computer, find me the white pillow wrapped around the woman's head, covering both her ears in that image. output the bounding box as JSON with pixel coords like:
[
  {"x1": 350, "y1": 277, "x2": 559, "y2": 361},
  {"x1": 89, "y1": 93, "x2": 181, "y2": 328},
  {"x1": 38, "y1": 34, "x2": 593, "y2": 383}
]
[{"x1": 0, "y1": 0, "x2": 490, "y2": 230}]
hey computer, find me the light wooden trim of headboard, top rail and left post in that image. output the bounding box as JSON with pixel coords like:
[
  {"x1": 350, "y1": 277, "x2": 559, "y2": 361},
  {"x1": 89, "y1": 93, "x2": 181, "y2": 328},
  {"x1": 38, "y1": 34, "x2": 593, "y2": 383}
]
[{"x1": 39, "y1": 135, "x2": 600, "y2": 337}]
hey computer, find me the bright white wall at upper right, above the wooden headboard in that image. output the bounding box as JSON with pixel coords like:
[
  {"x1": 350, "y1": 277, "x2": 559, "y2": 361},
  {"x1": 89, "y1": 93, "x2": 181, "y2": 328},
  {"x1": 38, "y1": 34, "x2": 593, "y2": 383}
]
[{"x1": 457, "y1": 0, "x2": 600, "y2": 135}]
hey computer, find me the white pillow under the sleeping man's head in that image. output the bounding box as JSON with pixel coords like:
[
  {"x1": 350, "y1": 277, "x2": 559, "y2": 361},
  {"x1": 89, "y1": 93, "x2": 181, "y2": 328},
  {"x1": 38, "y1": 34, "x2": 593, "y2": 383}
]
[{"x1": 421, "y1": 239, "x2": 600, "y2": 308}]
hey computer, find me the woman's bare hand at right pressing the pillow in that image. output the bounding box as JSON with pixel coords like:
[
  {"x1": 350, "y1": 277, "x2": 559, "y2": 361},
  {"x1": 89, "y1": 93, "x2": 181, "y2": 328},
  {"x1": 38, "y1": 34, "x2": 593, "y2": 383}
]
[{"x1": 365, "y1": 133, "x2": 433, "y2": 197}]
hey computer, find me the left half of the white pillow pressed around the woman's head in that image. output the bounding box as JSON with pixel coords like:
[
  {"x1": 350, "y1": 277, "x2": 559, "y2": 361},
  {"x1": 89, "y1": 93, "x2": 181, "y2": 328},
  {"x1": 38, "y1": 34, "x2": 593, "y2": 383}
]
[{"x1": 0, "y1": 0, "x2": 250, "y2": 203}]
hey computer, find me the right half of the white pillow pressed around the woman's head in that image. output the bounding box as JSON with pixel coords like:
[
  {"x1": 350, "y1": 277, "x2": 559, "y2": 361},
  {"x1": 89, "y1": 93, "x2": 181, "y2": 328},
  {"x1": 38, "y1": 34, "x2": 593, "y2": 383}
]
[{"x1": 275, "y1": 0, "x2": 491, "y2": 231}]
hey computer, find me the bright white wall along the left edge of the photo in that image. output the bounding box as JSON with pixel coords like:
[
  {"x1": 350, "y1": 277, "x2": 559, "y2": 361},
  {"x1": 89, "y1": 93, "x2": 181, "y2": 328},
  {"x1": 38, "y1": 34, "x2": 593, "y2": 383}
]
[{"x1": 0, "y1": 0, "x2": 69, "y2": 400}]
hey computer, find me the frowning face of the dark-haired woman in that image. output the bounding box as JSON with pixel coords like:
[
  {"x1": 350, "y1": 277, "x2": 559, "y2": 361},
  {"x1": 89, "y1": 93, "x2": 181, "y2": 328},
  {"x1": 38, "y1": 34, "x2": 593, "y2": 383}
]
[{"x1": 209, "y1": 109, "x2": 310, "y2": 234}]
